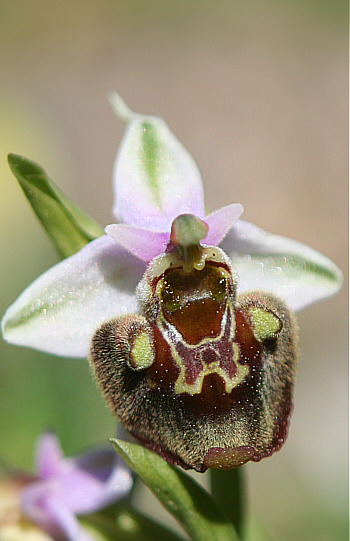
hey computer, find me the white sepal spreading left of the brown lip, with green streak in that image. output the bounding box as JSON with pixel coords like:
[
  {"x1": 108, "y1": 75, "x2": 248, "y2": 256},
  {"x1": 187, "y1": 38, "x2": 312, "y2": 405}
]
[{"x1": 2, "y1": 235, "x2": 145, "y2": 357}]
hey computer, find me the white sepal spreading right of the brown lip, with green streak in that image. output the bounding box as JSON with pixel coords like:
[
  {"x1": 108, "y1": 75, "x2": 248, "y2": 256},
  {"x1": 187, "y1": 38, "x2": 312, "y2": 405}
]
[{"x1": 220, "y1": 220, "x2": 343, "y2": 311}]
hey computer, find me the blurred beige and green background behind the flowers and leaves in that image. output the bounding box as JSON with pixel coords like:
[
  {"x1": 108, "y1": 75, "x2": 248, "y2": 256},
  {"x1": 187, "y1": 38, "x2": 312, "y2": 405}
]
[{"x1": 0, "y1": 0, "x2": 348, "y2": 541}]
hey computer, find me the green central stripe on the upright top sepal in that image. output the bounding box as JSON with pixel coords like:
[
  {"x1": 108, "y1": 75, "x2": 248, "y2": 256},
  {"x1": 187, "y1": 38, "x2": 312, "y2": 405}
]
[{"x1": 141, "y1": 122, "x2": 161, "y2": 207}]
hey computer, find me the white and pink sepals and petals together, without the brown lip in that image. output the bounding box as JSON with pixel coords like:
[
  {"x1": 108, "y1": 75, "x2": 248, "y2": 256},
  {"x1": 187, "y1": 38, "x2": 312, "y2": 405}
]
[{"x1": 2, "y1": 94, "x2": 342, "y2": 358}]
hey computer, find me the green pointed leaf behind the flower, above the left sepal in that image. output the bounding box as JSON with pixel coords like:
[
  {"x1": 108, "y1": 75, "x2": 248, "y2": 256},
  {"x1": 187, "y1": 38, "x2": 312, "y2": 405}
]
[{"x1": 8, "y1": 154, "x2": 104, "y2": 258}]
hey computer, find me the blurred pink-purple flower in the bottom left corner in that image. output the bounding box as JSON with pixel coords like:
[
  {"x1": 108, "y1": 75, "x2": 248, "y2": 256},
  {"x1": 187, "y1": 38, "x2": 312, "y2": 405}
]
[{"x1": 0, "y1": 432, "x2": 132, "y2": 541}]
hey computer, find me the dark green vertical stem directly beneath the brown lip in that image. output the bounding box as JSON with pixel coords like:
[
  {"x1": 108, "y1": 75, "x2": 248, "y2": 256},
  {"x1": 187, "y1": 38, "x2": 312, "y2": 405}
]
[{"x1": 210, "y1": 467, "x2": 246, "y2": 539}]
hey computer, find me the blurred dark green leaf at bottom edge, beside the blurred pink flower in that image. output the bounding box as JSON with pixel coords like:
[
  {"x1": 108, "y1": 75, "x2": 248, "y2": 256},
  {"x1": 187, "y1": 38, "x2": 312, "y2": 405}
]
[{"x1": 80, "y1": 503, "x2": 184, "y2": 541}]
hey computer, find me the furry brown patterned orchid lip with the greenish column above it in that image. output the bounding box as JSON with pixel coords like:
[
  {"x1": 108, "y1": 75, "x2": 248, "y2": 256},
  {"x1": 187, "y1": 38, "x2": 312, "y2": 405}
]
[{"x1": 91, "y1": 215, "x2": 297, "y2": 472}]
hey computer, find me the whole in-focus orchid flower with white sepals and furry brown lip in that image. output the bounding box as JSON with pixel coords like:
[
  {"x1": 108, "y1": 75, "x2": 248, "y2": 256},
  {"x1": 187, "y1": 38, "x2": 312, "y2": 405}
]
[{"x1": 2, "y1": 94, "x2": 342, "y2": 471}]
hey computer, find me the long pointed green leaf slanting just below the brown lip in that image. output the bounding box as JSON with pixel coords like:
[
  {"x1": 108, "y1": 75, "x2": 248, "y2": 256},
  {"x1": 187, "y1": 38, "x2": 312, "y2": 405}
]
[{"x1": 111, "y1": 439, "x2": 238, "y2": 541}]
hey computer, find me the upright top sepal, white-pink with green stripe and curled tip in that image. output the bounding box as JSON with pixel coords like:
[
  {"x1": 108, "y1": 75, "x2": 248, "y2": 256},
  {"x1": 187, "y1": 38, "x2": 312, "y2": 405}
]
[{"x1": 113, "y1": 92, "x2": 204, "y2": 232}]
